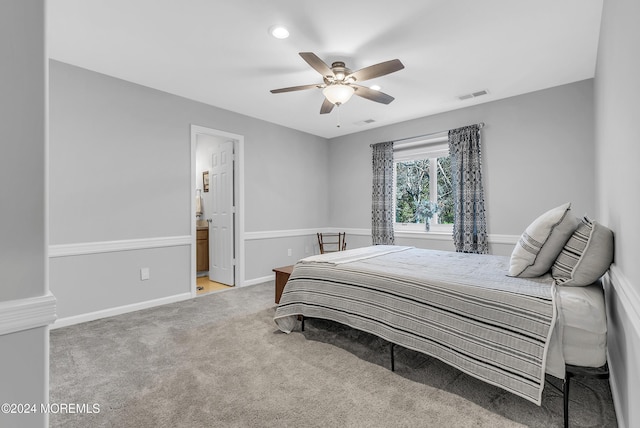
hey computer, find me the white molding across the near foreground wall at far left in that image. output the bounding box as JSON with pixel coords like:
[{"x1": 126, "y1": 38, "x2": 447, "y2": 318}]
[{"x1": 0, "y1": 293, "x2": 56, "y2": 335}]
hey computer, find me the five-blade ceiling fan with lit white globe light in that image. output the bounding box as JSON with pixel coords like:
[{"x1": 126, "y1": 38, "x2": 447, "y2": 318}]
[{"x1": 271, "y1": 52, "x2": 404, "y2": 114}]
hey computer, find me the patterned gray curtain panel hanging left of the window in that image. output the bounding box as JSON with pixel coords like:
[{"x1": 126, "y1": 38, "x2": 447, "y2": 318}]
[{"x1": 371, "y1": 141, "x2": 394, "y2": 245}]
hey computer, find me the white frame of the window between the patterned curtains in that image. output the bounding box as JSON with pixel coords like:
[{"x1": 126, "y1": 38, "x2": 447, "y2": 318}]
[{"x1": 393, "y1": 132, "x2": 453, "y2": 234}]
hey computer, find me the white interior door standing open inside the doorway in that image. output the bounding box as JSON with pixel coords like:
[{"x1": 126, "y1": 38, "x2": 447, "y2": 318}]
[{"x1": 209, "y1": 141, "x2": 235, "y2": 285}]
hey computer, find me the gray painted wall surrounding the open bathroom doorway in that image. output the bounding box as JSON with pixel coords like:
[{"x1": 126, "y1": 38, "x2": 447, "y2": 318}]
[{"x1": 49, "y1": 61, "x2": 329, "y2": 318}]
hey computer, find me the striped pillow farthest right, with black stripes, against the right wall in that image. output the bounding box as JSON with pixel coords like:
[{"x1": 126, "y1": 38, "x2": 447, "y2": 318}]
[{"x1": 551, "y1": 217, "x2": 613, "y2": 286}]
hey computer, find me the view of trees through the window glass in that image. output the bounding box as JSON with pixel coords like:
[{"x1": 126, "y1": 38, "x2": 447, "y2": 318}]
[{"x1": 396, "y1": 156, "x2": 453, "y2": 224}]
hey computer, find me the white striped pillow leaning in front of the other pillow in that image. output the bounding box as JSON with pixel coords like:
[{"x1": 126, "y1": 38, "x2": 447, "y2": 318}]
[{"x1": 509, "y1": 202, "x2": 579, "y2": 278}]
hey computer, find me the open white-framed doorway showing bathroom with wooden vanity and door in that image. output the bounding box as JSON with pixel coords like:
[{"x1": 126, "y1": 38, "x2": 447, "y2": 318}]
[{"x1": 191, "y1": 125, "x2": 244, "y2": 296}]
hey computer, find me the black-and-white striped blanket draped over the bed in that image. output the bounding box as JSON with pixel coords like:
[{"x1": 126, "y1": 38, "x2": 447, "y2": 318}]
[{"x1": 274, "y1": 245, "x2": 556, "y2": 405}]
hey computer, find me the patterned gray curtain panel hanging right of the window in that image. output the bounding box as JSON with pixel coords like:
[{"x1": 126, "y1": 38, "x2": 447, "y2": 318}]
[{"x1": 449, "y1": 125, "x2": 489, "y2": 254}]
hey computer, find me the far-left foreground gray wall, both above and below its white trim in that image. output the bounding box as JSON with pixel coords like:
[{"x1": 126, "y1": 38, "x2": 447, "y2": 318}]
[{"x1": 0, "y1": 0, "x2": 49, "y2": 427}]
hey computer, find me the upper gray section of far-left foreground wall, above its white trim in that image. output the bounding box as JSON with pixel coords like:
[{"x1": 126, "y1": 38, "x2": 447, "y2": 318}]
[{"x1": 0, "y1": 0, "x2": 45, "y2": 301}]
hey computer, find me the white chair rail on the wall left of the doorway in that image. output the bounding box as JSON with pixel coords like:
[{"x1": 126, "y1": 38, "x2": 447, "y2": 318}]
[{"x1": 49, "y1": 235, "x2": 194, "y2": 258}]
